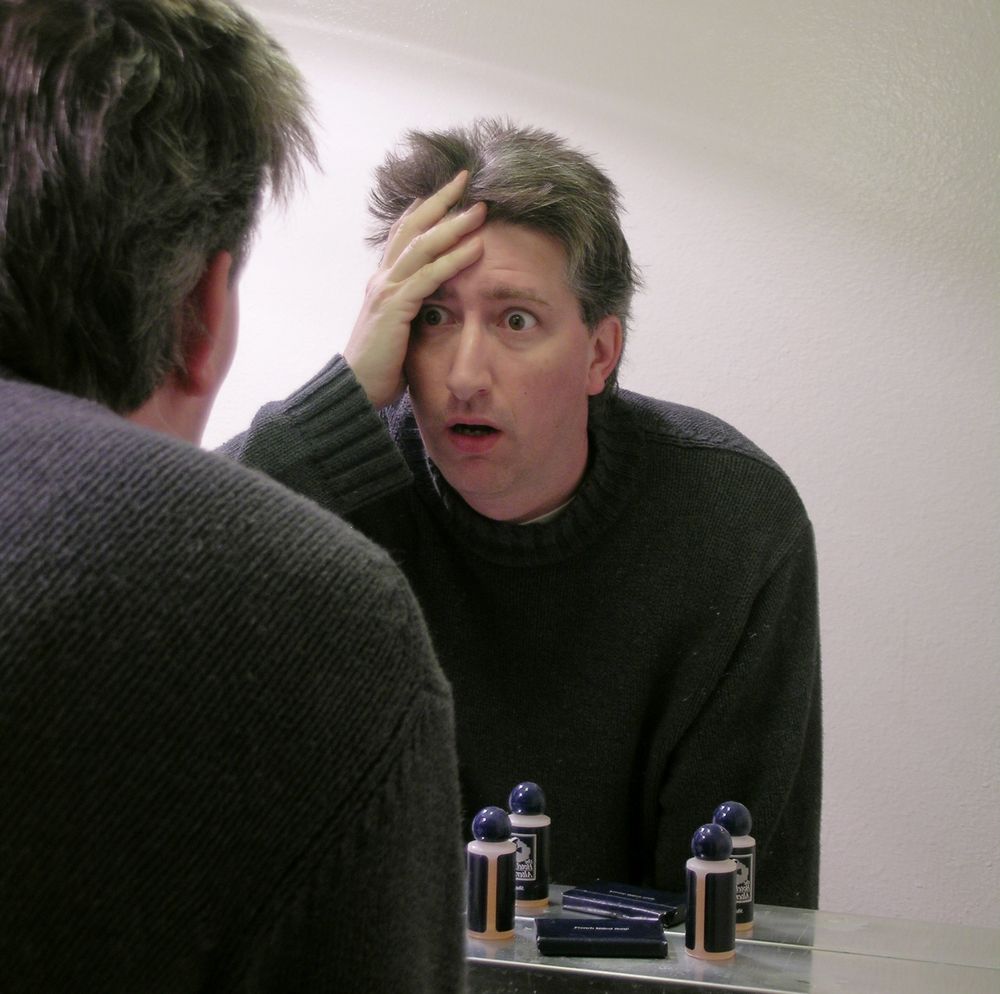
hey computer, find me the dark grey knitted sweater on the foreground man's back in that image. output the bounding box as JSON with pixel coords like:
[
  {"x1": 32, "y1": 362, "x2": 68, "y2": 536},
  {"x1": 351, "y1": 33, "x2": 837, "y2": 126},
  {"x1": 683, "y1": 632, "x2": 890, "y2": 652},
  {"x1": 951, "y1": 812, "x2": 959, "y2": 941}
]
[{"x1": 0, "y1": 374, "x2": 464, "y2": 994}]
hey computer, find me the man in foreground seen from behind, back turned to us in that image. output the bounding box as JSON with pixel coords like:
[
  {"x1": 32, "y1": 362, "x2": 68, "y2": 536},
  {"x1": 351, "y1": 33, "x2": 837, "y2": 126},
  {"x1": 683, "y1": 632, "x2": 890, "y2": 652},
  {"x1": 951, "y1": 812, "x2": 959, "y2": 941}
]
[{"x1": 0, "y1": 0, "x2": 463, "y2": 992}]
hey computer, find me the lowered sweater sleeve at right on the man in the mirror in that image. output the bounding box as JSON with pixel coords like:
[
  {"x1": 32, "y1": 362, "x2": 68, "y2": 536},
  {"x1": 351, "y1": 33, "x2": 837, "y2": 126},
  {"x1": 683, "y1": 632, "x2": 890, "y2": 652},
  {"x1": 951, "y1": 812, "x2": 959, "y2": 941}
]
[{"x1": 655, "y1": 522, "x2": 822, "y2": 908}]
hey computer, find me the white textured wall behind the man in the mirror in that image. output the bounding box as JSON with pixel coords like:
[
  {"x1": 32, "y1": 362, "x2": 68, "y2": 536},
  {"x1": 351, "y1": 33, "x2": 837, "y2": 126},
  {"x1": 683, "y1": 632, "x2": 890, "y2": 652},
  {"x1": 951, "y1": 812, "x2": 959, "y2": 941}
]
[{"x1": 206, "y1": 0, "x2": 1000, "y2": 926}]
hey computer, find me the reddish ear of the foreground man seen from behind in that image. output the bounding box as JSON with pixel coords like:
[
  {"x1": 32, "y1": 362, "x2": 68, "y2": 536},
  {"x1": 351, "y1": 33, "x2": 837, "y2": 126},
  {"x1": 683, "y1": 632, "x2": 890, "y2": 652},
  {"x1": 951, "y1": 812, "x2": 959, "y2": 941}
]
[{"x1": 178, "y1": 252, "x2": 236, "y2": 396}]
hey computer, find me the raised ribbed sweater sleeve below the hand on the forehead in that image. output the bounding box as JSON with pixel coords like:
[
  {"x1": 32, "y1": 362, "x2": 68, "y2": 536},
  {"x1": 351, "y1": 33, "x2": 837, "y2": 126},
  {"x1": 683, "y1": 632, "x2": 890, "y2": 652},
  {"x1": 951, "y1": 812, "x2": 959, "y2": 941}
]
[{"x1": 219, "y1": 356, "x2": 412, "y2": 516}]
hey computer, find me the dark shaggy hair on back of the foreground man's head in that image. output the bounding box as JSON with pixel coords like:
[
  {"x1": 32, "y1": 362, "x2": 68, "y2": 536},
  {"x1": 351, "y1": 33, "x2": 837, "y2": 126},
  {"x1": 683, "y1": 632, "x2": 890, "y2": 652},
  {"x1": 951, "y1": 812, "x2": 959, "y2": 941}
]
[{"x1": 0, "y1": 0, "x2": 314, "y2": 413}]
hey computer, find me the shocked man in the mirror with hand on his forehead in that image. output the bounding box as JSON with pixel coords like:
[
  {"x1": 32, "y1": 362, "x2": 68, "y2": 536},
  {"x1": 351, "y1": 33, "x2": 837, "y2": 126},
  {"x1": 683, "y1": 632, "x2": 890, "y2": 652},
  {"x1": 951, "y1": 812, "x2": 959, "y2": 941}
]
[{"x1": 229, "y1": 121, "x2": 821, "y2": 906}]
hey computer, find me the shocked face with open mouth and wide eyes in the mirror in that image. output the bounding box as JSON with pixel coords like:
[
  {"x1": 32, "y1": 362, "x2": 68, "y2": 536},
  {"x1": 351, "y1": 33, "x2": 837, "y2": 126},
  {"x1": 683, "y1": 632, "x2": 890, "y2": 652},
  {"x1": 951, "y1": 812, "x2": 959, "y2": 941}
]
[{"x1": 405, "y1": 222, "x2": 621, "y2": 521}]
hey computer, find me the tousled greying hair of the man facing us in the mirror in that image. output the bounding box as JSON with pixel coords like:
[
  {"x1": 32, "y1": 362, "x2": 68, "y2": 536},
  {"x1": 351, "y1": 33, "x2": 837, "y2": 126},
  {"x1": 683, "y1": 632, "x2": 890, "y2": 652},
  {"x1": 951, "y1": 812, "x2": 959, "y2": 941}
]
[{"x1": 369, "y1": 118, "x2": 642, "y2": 385}]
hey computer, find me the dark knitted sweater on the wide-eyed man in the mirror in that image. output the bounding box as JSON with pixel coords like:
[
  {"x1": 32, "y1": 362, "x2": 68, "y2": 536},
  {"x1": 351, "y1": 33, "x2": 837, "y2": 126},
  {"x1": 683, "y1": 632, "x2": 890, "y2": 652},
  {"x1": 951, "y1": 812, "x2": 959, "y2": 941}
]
[{"x1": 227, "y1": 359, "x2": 821, "y2": 907}]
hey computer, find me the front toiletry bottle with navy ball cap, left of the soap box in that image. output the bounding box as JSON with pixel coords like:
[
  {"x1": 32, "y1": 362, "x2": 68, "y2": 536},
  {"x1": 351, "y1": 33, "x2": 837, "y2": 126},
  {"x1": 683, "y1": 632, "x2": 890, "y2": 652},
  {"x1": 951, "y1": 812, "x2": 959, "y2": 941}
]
[{"x1": 465, "y1": 807, "x2": 516, "y2": 939}]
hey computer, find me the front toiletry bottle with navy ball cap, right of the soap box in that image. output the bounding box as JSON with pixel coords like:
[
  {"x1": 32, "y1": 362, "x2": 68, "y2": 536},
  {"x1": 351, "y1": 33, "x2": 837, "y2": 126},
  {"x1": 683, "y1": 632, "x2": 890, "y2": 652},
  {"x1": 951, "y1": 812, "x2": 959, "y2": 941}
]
[{"x1": 684, "y1": 823, "x2": 738, "y2": 959}]
